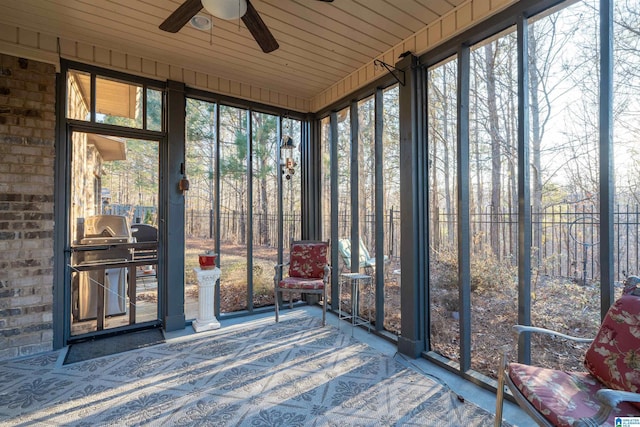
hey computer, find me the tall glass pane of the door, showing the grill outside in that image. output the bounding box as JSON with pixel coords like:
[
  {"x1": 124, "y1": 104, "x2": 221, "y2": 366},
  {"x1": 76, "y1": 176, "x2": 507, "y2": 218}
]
[{"x1": 67, "y1": 132, "x2": 160, "y2": 339}]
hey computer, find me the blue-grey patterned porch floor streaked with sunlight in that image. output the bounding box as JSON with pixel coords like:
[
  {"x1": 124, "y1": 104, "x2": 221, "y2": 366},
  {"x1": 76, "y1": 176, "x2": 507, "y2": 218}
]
[{"x1": 0, "y1": 310, "x2": 528, "y2": 426}]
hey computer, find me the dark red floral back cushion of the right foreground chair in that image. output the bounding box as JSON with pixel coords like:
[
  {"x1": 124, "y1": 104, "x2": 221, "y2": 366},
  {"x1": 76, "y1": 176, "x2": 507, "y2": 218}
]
[{"x1": 584, "y1": 294, "x2": 640, "y2": 409}]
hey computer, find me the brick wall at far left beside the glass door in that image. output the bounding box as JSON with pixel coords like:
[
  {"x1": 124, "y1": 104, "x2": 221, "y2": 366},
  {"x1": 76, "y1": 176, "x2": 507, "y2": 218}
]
[{"x1": 0, "y1": 54, "x2": 56, "y2": 360}]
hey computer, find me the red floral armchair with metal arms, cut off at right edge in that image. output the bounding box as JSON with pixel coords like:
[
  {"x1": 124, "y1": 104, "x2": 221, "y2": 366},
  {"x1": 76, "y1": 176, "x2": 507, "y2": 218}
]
[{"x1": 495, "y1": 287, "x2": 640, "y2": 426}]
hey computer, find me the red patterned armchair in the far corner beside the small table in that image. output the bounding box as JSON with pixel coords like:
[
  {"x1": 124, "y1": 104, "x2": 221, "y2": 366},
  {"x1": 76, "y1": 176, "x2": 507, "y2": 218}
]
[{"x1": 274, "y1": 240, "x2": 331, "y2": 326}]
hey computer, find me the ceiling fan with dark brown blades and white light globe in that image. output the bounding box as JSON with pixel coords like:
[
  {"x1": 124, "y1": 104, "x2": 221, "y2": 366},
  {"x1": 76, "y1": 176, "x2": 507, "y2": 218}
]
[{"x1": 160, "y1": 0, "x2": 333, "y2": 53}]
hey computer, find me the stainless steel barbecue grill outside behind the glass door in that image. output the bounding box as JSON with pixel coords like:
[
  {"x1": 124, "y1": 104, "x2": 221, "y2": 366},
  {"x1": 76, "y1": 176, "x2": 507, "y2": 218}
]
[{"x1": 74, "y1": 215, "x2": 134, "y2": 320}]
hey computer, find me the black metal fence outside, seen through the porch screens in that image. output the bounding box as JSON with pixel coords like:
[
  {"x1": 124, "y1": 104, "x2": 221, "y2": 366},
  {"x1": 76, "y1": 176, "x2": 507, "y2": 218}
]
[{"x1": 109, "y1": 204, "x2": 640, "y2": 281}]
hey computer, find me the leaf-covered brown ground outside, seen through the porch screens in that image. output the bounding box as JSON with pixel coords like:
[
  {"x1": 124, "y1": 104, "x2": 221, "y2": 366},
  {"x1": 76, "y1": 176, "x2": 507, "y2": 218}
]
[{"x1": 186, "y1": 239, "x2": 620, "y2": 378}]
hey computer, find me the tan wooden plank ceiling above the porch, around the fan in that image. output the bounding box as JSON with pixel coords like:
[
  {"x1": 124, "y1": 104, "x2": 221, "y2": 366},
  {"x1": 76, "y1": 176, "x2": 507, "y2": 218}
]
[{"x1": 0, "y1": 0, "x2": 465, "y2": 99}]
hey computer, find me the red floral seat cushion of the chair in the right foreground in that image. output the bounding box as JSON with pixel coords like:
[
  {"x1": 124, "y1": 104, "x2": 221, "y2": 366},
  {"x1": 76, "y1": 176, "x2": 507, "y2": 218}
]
[{"x1": 509, "y1": 363, "x2": 640, "y2": 426}]
